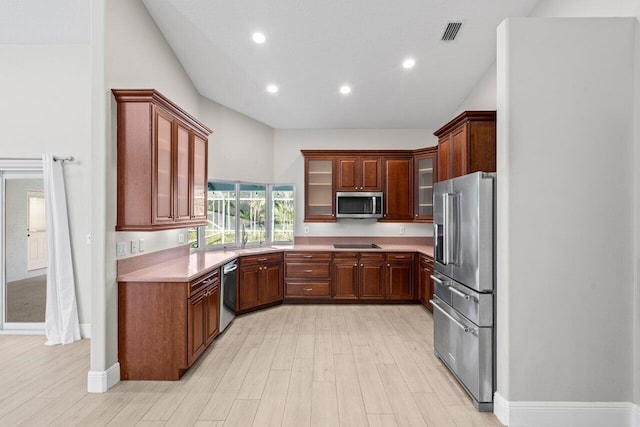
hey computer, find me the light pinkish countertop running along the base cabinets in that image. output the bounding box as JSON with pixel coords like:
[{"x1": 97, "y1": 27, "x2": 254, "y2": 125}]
[{"x1": 118, "y1": 244, "x2": 433, "y2": 282}]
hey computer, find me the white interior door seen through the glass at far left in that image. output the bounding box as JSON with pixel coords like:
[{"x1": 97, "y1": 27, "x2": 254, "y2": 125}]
[{"x1": 27, "y1": 190, "x2": 47, "y2": 271}]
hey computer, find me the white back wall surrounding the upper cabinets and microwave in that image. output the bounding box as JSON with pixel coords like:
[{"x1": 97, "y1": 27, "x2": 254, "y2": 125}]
[{"x1": 273, "y1": 129, "x2": 438, "y2": 236}]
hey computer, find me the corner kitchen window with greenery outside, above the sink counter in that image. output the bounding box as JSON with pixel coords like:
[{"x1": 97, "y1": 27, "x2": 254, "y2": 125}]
[{"x1": 192, "y1": 181, "x2": 295, "y2": 249}]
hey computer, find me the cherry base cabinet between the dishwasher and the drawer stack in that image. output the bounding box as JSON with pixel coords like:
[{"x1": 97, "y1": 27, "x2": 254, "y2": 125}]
[{"x1": 236, "y1": 253, "x2": 283, "y2": 312}]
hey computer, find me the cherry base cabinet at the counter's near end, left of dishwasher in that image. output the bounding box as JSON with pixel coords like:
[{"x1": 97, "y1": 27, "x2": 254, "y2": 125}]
[{"x1": 118, "y1": 269, "x2": 220, "y2": 380}]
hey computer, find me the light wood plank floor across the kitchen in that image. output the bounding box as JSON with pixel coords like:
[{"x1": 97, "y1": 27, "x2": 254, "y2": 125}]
[{"x1": 0, "y1": 305, "x2": 501, "y2": 427}]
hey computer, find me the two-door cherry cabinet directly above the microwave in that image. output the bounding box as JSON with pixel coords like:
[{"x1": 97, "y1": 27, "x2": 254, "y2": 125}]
[{"x1": 336, "y1": 156, "x2": 382, "y2": 191}]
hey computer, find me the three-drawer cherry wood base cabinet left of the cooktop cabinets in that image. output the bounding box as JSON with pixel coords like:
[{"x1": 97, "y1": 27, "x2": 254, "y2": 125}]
[{"x1": 284, "y1": 252, "x2": 331, "y2": 301}]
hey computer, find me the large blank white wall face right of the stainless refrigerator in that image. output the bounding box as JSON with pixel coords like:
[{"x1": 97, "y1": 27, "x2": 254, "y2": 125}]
[{"x1": 497, "y1": 18, "x2": 637, "y2": 408}]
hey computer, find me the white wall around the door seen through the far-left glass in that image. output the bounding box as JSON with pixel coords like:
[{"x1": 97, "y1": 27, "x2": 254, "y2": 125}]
[{"x1": 5, "y1": 179, "x2": 47, "y2": 282}]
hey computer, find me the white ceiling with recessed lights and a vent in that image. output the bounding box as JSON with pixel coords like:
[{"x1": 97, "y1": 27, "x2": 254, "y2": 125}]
[{"x1": 143, "y1": 0, "x2": 537, "y2": 129}]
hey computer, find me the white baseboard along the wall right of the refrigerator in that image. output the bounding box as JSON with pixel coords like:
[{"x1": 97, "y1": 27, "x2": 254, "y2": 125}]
[{"x1": 493, "y1": 393, "x2": 640, "y2": 427}]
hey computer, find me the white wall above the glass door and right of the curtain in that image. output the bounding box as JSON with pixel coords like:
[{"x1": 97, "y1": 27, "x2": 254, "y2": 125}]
[{"x1": 0, "y1": 44, "x2": 92, "y2": 324}]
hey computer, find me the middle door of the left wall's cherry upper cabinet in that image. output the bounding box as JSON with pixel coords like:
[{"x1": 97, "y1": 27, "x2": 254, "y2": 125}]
[{"x1": 174, "y1": 121, "x2": 191, "y2": 221}]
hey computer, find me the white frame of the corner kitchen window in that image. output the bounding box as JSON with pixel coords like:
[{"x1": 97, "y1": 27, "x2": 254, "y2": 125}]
[{"x1": 191, "y1": 179, "x2": 297, "y2": 252}]
